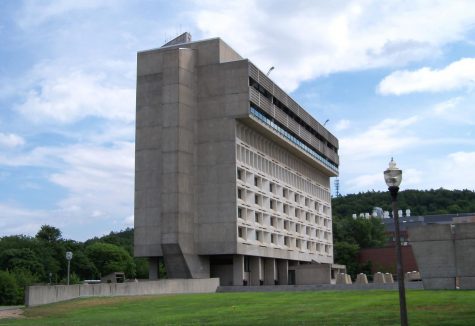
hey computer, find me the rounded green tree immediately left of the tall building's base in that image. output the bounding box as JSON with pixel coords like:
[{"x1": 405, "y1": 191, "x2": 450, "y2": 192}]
[{"x1": 86, "y1": 242, "x2": 135, "y2": 277}]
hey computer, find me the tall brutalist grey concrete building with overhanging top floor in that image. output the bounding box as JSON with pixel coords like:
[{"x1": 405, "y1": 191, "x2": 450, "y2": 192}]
[{"x1": 135, "y1": 33, "x2": 339, "y2": 285}]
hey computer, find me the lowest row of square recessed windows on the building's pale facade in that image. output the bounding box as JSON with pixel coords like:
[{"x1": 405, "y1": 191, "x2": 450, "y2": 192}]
[{"x1": 238, "y1": 226, "x2": 332, "y2": 256}]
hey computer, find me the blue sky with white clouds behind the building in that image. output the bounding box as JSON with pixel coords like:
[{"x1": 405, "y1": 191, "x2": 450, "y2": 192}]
[{"x1": 0, "y1": 0, "x2": 475, "y2": 241}]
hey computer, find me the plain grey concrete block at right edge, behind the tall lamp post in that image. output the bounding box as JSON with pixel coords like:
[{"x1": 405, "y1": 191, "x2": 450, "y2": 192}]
[{"x1": 408, "y1": 223, "x2": 475, "y2": 289}]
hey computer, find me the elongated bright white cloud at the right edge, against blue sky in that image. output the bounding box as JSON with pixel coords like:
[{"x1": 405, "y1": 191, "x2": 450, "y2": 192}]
[{"x1": 378, "y1": 58, "x2": 475, "y2": 95}]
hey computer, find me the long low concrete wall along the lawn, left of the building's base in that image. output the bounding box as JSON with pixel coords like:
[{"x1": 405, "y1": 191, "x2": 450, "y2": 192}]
[{"x1": 25, "y1": 278, "x2": 219, "y2": 307}]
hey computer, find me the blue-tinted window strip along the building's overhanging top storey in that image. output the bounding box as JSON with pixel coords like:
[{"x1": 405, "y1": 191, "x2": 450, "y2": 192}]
[{"x1": 249, "y1": 104, "x2": 338, "y2": 173}]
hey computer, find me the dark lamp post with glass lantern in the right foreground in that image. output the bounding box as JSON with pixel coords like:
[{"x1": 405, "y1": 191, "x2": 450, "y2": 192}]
[{"x1": 384, "y1": 158, "x2": 408, "y2": 326}]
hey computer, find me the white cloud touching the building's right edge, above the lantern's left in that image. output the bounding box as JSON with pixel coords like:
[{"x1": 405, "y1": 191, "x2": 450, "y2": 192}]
[{"x1": 340, "y1": 117, "x2": 420, "y2": 161}]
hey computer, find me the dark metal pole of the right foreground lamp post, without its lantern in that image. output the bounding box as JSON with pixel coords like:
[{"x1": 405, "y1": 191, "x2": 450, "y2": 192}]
[{"x1": 389, "y1": 186, "x2": 408, "y2": 326}]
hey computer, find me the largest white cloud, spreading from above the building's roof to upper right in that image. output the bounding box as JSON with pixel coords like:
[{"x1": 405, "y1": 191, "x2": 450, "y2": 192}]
[{"x1": 189, "y1": 0, "x2": 475, "y2": 91}]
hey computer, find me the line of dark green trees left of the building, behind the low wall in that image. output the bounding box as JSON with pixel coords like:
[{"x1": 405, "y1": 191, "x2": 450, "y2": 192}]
[{"x1": 0, "y1": 225, "x2": 148, "y2": 305}]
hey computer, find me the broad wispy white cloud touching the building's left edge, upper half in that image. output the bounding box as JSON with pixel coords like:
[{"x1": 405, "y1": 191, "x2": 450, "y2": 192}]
[{"x1": 16, "y1": 67, "x2": 135, "y2": 123}]
